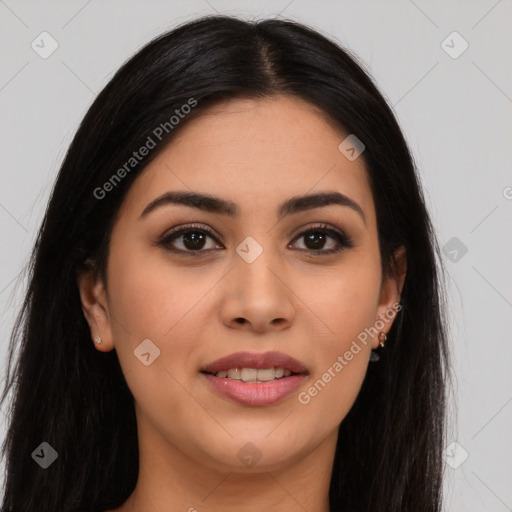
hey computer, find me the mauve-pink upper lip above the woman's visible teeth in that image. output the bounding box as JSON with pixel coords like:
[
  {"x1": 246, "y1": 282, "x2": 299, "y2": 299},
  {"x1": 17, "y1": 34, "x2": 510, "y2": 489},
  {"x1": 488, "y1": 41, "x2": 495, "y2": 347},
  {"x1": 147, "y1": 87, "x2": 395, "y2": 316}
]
[{"x1": 201, "y1": 352, "x2": 307, "y2": 374}]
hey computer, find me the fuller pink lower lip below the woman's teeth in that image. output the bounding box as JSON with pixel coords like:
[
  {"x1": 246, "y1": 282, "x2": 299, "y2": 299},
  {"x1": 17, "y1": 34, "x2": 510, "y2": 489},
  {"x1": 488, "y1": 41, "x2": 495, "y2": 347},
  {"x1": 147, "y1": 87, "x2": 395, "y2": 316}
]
[{"x1": 203, "y1": 373, "x2": 307, "y2": 407}]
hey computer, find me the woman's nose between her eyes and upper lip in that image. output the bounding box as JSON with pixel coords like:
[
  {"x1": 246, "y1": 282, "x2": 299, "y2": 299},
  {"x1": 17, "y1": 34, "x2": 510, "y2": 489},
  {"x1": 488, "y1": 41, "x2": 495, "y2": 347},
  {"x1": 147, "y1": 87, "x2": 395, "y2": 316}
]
[{"x1": 221, "y1": 251, "x2": 295, "y2": 333}]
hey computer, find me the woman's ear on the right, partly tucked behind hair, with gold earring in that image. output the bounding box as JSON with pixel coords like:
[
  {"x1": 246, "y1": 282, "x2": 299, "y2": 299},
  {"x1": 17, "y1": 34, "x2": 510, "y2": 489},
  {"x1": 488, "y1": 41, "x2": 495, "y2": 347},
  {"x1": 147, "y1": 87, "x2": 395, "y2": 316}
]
[{"x1": 373, "y1": 246, "x2": 407, "y2": 348}]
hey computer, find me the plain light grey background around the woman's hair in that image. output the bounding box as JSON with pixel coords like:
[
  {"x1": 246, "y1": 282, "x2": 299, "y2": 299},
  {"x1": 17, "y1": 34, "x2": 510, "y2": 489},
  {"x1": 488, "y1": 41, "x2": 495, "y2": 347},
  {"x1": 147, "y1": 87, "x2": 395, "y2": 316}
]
[{"x1": 0, "y1": 0, "x2": 512, "y2": 512}]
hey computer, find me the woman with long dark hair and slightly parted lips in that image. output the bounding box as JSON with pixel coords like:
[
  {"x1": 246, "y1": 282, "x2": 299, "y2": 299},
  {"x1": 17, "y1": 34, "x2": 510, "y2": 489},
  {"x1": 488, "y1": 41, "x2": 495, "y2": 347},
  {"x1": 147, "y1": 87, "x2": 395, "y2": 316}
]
[{"x1": 2, "y1": 16, "x2": 448, "y2": 512}]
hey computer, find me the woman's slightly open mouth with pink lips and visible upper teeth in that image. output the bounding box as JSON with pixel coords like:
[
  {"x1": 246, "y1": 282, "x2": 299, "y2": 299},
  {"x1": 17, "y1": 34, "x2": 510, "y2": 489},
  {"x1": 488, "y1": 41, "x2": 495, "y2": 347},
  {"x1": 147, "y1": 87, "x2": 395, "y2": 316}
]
[{"x1": 201, "y1": 352, "x2": 309, "y2": 406}]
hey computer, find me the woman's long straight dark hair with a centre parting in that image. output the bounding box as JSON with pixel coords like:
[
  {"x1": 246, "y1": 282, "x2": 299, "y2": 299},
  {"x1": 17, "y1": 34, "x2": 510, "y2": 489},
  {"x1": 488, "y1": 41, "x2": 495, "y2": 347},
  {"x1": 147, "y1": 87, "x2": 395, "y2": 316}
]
[{"x1": 0, "y1": 16, "x2": 448, "y2": 512}]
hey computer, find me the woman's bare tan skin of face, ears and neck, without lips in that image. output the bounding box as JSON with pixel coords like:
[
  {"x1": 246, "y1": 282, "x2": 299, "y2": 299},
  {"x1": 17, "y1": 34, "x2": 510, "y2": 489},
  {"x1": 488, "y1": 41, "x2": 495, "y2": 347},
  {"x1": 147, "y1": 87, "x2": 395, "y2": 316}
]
[{"x1": 78, "y1": 96, "x2": 405, "y2": 512}]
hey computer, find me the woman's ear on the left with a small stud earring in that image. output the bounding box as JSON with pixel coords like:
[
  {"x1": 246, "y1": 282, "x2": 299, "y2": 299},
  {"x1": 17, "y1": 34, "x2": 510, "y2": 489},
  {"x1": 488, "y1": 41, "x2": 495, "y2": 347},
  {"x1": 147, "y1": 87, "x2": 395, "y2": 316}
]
[{"x1": 77, "y1": 270, "x2": 114, "y2": 352}]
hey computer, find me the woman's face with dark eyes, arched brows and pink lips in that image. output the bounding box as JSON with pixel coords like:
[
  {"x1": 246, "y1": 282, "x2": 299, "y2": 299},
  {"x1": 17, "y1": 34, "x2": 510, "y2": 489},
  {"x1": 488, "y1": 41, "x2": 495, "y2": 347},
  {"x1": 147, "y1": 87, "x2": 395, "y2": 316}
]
[{"x1": 79, "y1": 96, "x2": 401, "y2": 471}]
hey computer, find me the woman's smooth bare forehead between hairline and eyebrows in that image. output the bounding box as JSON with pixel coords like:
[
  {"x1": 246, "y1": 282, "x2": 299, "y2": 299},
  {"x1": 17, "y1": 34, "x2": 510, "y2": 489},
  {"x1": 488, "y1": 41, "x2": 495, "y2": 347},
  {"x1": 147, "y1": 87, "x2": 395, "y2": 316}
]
[{"x1": 120, "y1": 96, "x2": 373, "y2": 222}]
